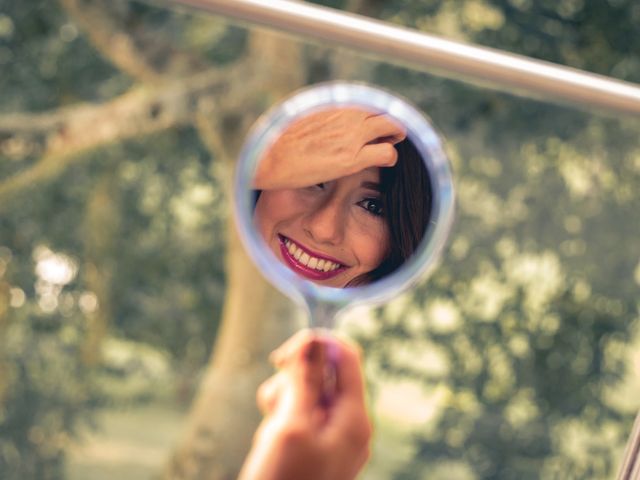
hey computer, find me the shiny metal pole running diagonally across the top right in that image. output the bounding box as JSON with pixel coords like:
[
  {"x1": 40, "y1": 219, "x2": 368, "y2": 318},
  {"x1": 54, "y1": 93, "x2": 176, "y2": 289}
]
[{"x1": 156, "y1": 0, "x2": 640, "y2": 114}]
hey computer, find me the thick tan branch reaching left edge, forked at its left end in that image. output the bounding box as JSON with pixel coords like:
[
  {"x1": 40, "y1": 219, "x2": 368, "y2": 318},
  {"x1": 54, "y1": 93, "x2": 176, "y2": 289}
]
[{"x1": 0, "y1": 63, "x2": 251, "y2": 209}]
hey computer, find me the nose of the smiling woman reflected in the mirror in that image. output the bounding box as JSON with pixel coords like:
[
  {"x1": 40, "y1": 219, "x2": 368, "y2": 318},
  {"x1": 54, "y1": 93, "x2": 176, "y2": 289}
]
[{"x1": 303, "y1": 196, "x2": 346, "y2": 245}]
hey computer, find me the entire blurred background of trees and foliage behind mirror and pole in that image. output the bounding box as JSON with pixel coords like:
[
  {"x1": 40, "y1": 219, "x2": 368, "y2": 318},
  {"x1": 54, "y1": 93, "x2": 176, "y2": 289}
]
[{"x1": 0, "y1": 0, "x2": 640, "y2": 480}]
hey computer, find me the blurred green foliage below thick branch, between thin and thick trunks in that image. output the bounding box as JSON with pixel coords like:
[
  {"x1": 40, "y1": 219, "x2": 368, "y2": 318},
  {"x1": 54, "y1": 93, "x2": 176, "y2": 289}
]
[{"x1": 100, "y1": 130, "x2": 226, "y2": 356}]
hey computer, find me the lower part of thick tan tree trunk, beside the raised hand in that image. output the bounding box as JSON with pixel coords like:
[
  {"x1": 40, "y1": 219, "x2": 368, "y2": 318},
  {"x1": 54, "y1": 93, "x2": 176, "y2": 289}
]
[{"x1": 165, "y1": 213, "x2": 300, "y2": 480}]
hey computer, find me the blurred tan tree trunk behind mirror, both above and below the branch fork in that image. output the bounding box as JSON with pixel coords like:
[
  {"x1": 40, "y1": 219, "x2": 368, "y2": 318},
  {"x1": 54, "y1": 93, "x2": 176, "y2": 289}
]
[{"x1": 162, "y1": 30, "x2": 305, "y2": 480}]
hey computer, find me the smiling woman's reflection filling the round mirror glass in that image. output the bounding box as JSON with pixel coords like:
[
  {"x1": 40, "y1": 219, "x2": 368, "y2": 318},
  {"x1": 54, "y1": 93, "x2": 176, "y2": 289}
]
[{"x1": 253, "y1": 107, "x2": 431, "y2": 288}]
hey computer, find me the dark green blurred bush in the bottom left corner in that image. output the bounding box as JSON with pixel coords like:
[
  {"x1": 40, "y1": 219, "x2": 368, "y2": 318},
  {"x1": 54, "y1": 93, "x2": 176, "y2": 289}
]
[{"x1": 0, "y1": 301, "x2": 99, "y2": 480}]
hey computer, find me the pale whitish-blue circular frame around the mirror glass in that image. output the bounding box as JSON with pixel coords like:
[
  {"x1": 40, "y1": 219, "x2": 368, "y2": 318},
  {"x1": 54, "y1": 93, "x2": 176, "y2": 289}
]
[{"x1": 234, "y1": 81, "x2": 455, "y2": 309}]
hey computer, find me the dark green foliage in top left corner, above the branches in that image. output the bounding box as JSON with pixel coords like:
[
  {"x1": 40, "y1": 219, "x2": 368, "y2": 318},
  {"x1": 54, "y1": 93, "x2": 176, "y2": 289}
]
[{"x1": 0, "y1": 0, "x2": 131, "y2": 112}]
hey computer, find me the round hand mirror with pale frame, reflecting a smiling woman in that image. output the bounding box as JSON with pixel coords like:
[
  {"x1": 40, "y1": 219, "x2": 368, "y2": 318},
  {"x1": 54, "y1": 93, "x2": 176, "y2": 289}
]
[{"x1": 235, "y1": 82, "x2": 454, "y2": 328}]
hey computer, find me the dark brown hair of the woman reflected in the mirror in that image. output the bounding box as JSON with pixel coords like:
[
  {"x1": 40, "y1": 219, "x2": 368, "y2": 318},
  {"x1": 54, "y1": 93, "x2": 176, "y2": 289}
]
[{"x1": 358, "y1": 138, "x2": 432, "y2": 286}]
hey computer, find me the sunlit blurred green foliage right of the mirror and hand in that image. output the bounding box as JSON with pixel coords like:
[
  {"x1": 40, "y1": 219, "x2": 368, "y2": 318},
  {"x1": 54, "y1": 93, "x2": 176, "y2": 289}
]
[{"x1": 340, "y1": 1, "x2": 640, "y2": 479}]
